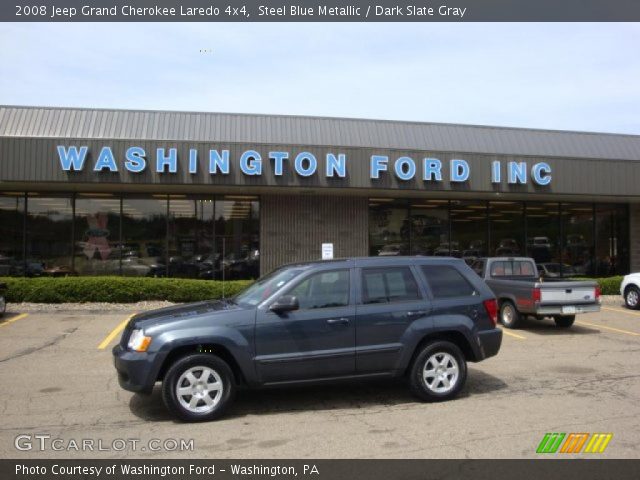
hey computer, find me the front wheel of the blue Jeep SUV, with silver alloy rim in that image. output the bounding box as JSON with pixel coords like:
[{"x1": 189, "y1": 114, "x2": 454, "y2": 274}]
[{"x1": 162, "y1": 354, "x2": 236, "y2": 422}]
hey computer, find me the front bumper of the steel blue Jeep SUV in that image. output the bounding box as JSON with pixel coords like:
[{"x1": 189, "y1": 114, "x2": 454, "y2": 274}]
[{"x1": 112, "y1": 345, "x2": 157, "y2": 393}]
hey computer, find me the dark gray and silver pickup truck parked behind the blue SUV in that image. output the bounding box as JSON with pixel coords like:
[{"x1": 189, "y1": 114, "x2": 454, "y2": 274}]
[{"x1": 472, "y1": 257, "x2": 600, "y2": 328}]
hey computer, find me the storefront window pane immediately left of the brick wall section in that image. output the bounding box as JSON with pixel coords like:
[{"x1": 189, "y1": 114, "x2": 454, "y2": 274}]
[{"x1": 214, "y1": 195, "x2": 260, "y2": 280}]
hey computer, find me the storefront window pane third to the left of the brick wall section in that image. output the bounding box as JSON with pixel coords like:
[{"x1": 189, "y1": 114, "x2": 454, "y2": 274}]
[{"x1": 118, "y1": 195, "x2": 168, "y2": 277}]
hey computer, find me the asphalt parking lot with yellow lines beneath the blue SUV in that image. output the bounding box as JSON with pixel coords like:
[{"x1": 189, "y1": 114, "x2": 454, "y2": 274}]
[{"x1": 0, "y1": 304, "x2": 640, "y2": 459}]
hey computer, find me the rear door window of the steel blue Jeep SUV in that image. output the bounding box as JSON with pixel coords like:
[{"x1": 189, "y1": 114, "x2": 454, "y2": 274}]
[{"x1": 362, "y1": 267, "x2": 421, "y2": 304}]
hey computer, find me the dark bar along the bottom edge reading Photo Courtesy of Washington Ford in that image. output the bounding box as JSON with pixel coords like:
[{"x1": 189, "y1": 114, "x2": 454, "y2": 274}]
[{"x1": 0, "y1": 460, "x2": 640, "y2": 480}]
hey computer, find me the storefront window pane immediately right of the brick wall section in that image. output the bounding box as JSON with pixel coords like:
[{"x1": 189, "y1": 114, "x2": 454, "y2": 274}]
[{"x1": 369, "y1": 198, "x2": 409, "y2": 256}]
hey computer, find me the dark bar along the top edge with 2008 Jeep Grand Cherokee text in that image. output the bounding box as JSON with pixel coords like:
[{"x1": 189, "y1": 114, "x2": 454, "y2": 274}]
[{"x1": 0, "y1": 0, "x2": 640, "y2": 22}]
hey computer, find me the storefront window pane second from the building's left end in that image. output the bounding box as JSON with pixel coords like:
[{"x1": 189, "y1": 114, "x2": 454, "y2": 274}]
[{"x1": 25, "y1": 194, "x2": 77, "y2": 277}]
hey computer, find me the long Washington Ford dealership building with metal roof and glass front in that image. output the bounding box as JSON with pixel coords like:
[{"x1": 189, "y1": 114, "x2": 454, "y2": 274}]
[{"x1": 0, "y1": 106, "x2": 640, "y2": 279}]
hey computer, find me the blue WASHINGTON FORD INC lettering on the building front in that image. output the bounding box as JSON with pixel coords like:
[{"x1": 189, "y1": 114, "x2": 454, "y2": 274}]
[{"x1": 57, "y1": 145, "x2": 552, "y2": 185}]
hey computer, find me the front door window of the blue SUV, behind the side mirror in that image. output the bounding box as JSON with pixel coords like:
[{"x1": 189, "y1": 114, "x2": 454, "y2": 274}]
[{"x1": 289, "y1": 270, "x2": 349, "y2": 310}]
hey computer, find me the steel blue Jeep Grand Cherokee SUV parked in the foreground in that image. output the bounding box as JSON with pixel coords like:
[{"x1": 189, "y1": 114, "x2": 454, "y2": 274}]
[{"x1": 113, "y1": 257, "x2": 502, "y2": 421}]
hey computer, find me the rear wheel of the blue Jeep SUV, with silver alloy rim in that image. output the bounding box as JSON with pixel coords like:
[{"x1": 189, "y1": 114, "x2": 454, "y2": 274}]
[{"x1": 409, "y1": 340, "x2": 467, "y2": 402}]
